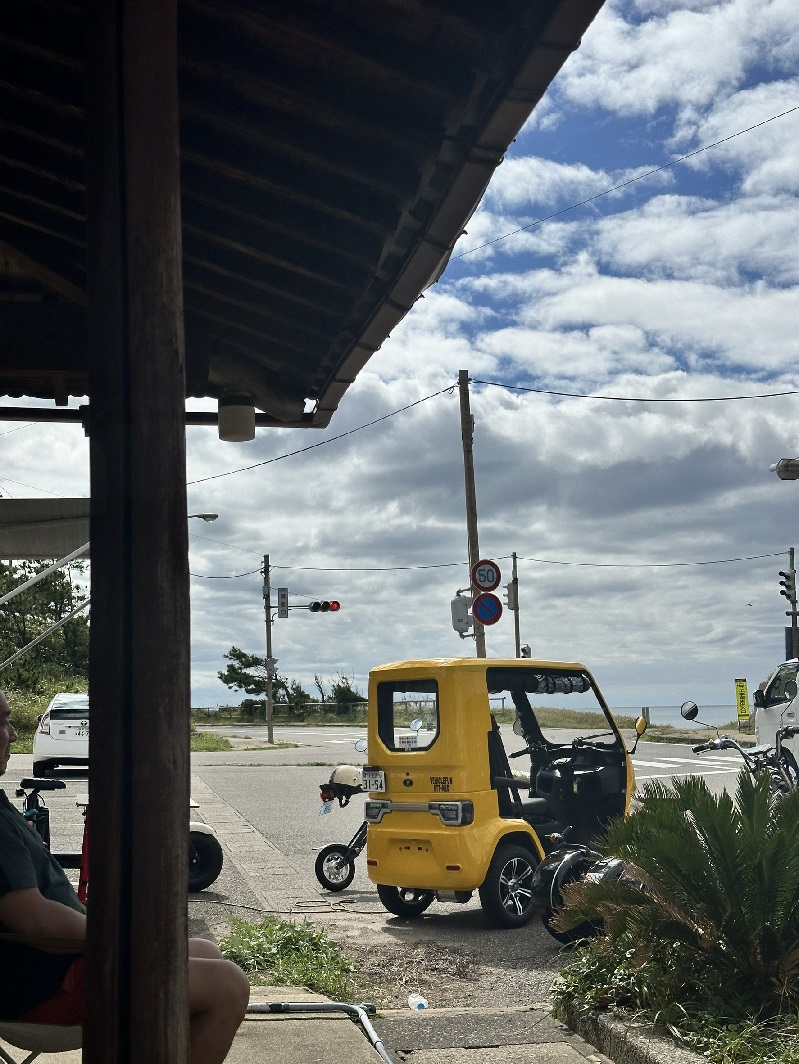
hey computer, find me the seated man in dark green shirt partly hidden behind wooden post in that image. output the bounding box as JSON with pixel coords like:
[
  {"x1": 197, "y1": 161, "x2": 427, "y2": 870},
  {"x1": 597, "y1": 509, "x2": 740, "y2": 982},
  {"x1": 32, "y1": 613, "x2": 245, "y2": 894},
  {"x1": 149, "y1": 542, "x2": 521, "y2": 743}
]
[{"x1": 0, "y1": 692, "x2": 250, "y2": 1064}]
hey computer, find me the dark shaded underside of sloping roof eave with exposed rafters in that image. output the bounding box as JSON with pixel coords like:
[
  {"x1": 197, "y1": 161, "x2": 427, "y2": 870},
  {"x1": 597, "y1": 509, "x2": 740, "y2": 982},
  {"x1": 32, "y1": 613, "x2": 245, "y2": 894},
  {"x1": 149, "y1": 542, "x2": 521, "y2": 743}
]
[{"x1": 0, "y1": 0, "x2": 602, "y2": 427}]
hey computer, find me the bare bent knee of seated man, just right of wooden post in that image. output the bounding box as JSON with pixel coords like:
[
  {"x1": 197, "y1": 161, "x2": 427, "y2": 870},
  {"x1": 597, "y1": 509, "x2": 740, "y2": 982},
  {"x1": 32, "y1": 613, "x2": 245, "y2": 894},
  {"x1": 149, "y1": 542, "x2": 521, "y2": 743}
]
[{"x1": 188, "y1": 953, "x2": 250, "y2": 1064}]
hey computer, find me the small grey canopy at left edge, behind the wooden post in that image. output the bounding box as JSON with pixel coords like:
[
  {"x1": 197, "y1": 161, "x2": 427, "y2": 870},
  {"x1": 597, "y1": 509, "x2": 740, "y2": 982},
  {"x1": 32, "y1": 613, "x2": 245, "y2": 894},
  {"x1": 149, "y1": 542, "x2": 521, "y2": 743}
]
[{"x1": 0, "y1": 499, "x2": 89, "y2": 561}]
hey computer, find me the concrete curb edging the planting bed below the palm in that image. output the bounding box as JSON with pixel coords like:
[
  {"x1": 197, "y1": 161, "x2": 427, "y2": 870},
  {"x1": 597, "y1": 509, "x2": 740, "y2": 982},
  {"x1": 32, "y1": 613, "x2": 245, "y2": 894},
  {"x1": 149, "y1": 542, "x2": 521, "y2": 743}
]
[{"x1": 562, "y1": 1003, "x2": 706, "y2": 1064}]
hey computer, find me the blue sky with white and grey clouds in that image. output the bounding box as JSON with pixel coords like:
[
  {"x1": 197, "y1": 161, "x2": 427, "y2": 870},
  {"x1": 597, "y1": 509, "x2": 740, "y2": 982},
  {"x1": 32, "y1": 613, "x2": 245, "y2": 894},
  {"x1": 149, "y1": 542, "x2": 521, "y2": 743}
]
[{"x1": 0, "y1": 0, "x2": 799, "y2": 708}]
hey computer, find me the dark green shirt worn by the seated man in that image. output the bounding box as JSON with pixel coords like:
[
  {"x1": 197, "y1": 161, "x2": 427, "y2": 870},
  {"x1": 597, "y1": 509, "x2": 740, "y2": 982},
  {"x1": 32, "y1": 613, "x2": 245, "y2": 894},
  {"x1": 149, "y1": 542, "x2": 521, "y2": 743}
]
[{"x1": 0, "y1": 791, "x2": 83, "y2": 1019}]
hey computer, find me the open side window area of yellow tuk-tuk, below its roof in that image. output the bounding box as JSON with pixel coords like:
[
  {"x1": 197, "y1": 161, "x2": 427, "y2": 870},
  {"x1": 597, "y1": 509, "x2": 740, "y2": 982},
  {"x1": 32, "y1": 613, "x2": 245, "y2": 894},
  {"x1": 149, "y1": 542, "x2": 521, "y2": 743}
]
[{"x1": 486, "y1": 668, "x2": 619, "y2": 746}]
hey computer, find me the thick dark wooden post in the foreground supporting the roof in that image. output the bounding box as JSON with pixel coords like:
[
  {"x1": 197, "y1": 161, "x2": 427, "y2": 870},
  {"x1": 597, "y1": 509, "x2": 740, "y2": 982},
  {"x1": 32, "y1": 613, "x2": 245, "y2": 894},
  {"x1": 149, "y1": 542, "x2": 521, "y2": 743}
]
[{"x1": 83, "y1": 0, "x2": 189, "y2": 1064}]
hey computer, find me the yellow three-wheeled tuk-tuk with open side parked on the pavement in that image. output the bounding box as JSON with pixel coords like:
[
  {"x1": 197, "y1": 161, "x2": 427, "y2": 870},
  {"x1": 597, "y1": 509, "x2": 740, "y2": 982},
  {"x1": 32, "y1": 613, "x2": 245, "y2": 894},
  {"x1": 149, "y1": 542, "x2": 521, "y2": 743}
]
[{"x1": 364, "y1": 658, "x2": 634, "y2": 927}]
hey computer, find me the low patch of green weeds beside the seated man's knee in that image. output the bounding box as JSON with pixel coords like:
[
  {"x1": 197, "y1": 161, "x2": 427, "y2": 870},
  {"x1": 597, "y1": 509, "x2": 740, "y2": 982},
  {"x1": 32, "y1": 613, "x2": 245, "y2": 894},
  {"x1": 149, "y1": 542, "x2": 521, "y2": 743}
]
[{"x1": 219, "y1": 916, "x2": 355, "y2": 1001}]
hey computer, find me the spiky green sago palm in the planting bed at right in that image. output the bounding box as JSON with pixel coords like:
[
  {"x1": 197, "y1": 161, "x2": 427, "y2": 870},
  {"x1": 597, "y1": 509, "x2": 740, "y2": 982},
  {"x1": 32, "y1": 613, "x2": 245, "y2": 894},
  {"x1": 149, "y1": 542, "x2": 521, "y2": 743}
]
[{"x1": 554, "y1": 772, "x2": 799, "y2": 1013}]
